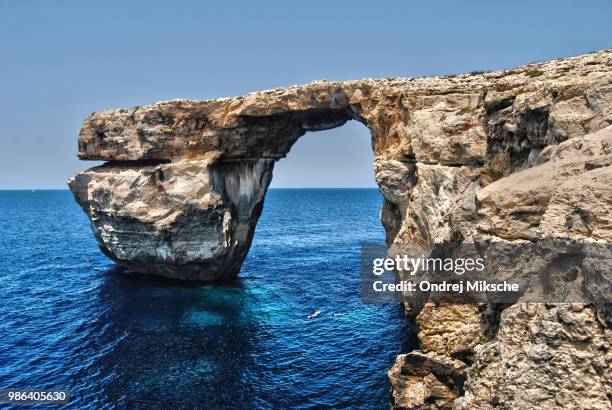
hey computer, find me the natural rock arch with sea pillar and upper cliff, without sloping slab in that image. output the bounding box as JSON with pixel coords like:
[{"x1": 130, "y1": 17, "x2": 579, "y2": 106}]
[{"x1": 69, "y1": 51, "x2": 612, "y2": 280}]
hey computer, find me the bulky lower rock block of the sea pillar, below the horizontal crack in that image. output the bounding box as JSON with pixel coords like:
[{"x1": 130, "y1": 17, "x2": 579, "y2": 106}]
[{"x1": 69, "y1": 153, "x2": 274, "y2": 280}]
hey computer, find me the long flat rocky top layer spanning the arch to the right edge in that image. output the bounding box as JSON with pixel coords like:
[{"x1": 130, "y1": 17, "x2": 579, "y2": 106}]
[{"x1": 79, "y1": 49, "x2": 612, "y2": 161}]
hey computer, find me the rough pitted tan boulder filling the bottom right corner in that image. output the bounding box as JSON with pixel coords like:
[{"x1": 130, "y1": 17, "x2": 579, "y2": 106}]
[{"x1": 455, "y1": 303, "x2": 612, "y2": 409}]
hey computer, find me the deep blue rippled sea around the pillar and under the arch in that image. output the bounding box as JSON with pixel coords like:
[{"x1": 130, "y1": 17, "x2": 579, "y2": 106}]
[{"x1": 0, "y1": 189, "x2": 410, "y2": 409}]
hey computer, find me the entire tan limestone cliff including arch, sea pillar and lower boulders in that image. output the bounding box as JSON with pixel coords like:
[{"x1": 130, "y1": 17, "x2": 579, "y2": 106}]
[{"x1": 69, "y1": 50, "x2": 612, "y2": 408}]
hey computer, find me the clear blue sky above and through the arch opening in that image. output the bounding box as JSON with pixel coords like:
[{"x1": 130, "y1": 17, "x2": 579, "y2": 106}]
[{"x1": 0, "y1": 0, "x2": 612, "y2": 189}]
